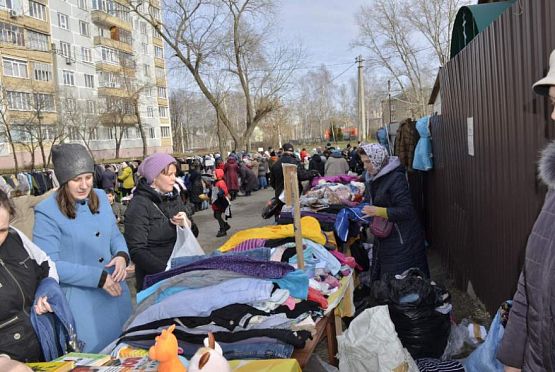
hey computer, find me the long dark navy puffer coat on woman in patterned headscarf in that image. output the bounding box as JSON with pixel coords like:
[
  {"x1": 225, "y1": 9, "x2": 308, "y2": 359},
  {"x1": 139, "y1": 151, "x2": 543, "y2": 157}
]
[{"x1": 366, "y1": 157, "x2": 430, "y2": 279}]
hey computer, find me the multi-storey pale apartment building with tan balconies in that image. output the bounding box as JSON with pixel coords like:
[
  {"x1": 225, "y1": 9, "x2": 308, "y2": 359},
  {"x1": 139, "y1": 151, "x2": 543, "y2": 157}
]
[{"x1": 0, "y1": 0, "x2": 172, "y2": 169}]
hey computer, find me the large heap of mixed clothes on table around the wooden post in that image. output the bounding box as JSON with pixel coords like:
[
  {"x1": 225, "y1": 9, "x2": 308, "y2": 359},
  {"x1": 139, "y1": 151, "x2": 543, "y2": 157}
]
[{"x1": 105, "y1": 217, "x2": 355, "y2": 359}]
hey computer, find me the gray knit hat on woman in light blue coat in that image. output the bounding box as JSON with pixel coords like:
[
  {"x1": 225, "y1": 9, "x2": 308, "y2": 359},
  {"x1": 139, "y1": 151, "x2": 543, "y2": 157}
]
[{"x1": 52, "y1": 143, "x2": 94, "y2": 185}]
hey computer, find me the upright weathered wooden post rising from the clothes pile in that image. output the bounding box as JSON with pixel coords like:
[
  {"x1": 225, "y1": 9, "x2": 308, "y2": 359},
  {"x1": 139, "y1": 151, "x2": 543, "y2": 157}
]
[{"x1": 281, "y1": 164, "x2": 304, "y2": 270}]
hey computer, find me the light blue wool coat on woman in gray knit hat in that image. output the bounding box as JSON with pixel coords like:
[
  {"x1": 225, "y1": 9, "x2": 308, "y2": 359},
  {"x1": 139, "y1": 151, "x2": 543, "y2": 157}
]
[{"x1": 33, "y1": 189, "x2": 131, "y2": 352}]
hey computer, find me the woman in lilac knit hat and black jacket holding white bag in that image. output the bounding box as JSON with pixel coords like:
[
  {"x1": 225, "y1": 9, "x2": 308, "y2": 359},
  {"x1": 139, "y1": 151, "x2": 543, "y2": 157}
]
[{"x1": 125, "y1": 153, "x2": 191, "y2": 290}]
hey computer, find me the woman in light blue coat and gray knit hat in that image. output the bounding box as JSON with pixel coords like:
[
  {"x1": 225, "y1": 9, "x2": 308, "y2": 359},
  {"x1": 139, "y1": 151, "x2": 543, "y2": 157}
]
[{"x1": 33, "y1": 144, "x2": 131, "y2": 352}]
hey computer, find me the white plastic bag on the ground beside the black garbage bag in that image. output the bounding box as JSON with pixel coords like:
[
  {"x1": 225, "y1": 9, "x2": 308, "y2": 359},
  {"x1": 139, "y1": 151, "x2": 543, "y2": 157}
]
[{"x1": 337, "y1": 306, "x2": 418, "y2": 372}]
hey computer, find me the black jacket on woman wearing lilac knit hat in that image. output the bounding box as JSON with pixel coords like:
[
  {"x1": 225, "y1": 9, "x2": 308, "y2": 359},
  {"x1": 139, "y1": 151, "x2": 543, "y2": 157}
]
[{"x1": 124, "y1": 178, "x2": 186, "y2": 290}]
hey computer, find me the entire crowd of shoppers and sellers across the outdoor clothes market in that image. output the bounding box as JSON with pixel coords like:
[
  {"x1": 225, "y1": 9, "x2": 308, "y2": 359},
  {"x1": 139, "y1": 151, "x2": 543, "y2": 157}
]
[{"x1": 0, "y1": 51, "x2": 555, "y2": 371}]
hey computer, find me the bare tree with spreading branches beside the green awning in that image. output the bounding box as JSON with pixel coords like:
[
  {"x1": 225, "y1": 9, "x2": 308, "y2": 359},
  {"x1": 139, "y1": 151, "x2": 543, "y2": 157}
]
[{"x1": 354, "y1": 0, "x2": 470, "y2": 115}]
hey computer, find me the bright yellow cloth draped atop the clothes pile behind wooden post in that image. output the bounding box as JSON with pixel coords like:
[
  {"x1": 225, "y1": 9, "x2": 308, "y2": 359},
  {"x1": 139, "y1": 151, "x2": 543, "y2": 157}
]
[{"x1": 219, "y1": 217, "x2": 326, "y2": 252}]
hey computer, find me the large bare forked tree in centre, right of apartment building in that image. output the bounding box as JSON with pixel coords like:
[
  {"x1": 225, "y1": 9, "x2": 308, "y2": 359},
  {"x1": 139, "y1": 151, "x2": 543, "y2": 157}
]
[{"x1": 127, "y1": 0, "x2": 301, "y2": 149}]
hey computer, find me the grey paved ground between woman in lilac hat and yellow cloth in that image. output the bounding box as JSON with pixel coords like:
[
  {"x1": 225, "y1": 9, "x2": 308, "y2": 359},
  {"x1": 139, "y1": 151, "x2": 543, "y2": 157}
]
[{"x1": 193, "y1": 189, "x2": 274, "y2": 253}]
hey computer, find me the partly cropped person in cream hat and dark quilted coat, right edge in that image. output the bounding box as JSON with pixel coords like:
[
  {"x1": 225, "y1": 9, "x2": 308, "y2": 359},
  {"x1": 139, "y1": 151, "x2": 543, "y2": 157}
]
[{"x1": 497, "y1": 50, "x2": 555, "y2": 372}]
